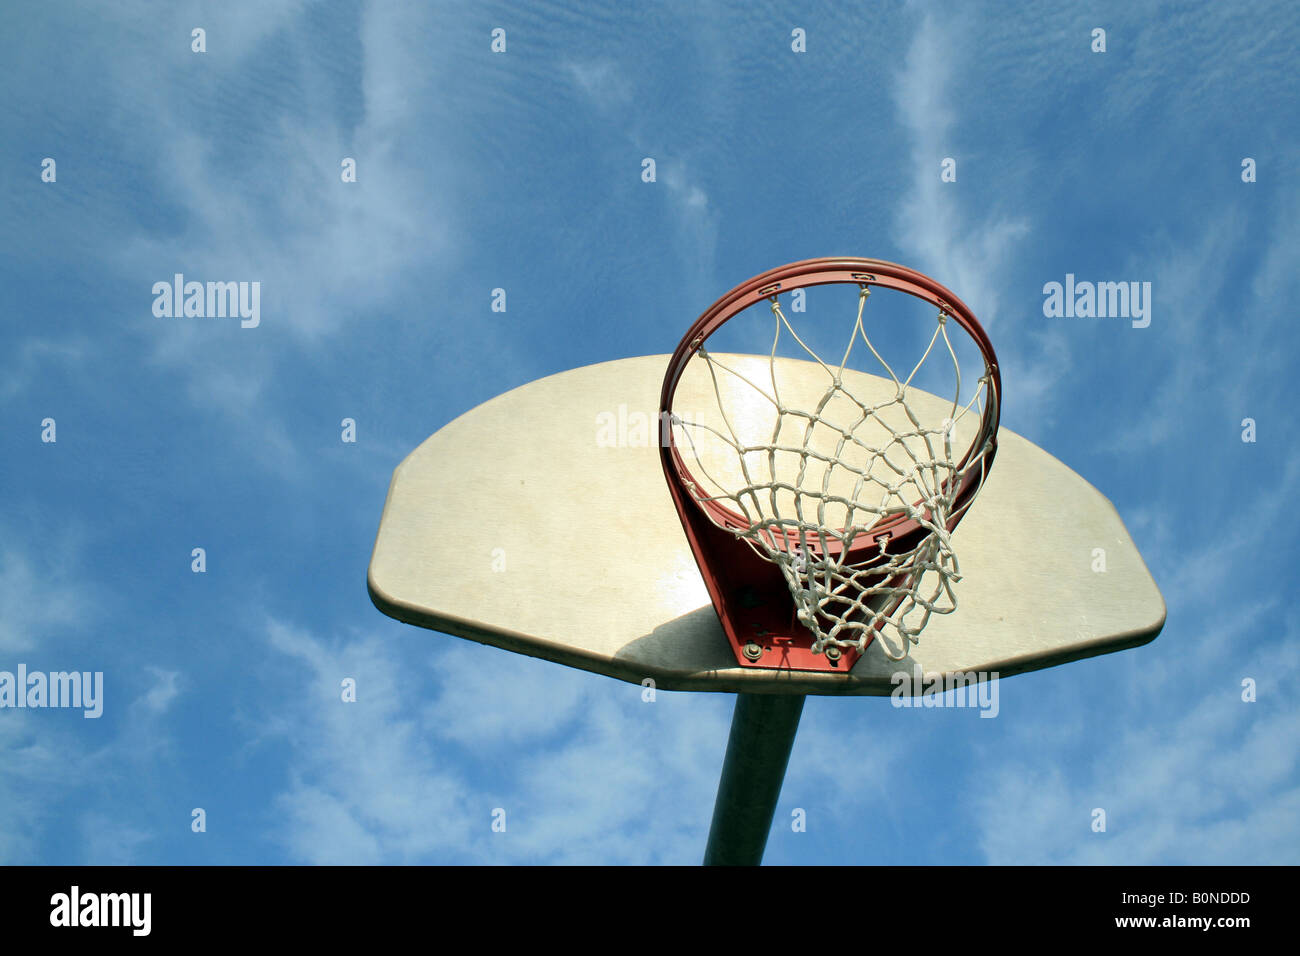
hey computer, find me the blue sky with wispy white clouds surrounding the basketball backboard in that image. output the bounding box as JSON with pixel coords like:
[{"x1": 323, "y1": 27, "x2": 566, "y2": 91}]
[{"x1": 0, "y1": 3, "x2": 1300, "y2": 864}]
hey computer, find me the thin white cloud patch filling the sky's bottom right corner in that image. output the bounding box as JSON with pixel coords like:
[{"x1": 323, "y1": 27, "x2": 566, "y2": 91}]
[{"x1": 975, "y1": 634, "x2": 1300, "y2": 865}]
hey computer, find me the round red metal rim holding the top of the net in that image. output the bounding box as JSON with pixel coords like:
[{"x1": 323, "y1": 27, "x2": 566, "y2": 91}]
[{"x1": 659, "y1": 258, "x2": 1002, "y2": 562}]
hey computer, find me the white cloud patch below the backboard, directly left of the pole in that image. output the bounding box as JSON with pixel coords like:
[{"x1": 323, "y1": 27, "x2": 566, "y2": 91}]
[{"x1": 260, "y1": 623, "x2": 729, "y2": 864}]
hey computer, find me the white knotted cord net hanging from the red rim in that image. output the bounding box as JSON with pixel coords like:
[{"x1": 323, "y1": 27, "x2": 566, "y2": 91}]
[{"x1": 671, "y1": 285, "x2": 997, "y2": 661}]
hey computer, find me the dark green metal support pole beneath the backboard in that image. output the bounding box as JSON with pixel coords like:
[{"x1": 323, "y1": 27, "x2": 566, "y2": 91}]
[{"x1": 705, "y1": 693, "x2": 803, "y2": 866}]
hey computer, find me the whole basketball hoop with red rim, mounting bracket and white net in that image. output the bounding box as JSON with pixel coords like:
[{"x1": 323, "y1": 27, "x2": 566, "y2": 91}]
[{"x1": 660, "y1": 259, "x2": 1001, "y2": 672}]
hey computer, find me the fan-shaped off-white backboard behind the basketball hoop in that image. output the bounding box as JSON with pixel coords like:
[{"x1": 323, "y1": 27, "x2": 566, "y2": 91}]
[{"x1": 368, "y1": 355, "x2": 1165, "y2": 695}]
